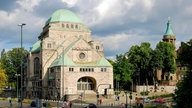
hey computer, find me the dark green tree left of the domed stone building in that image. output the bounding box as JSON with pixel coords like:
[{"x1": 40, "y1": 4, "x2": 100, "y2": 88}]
[{"x1": 0, "y1": 48, "x2": 27, "y2": 86}]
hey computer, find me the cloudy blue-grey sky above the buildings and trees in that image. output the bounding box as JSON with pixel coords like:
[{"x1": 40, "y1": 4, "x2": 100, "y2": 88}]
[{"x1": 0, "y1": 0, "x2": 192, "y2": 59}]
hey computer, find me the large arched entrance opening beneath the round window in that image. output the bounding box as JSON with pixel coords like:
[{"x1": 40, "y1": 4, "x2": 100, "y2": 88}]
[{"x1": 77, "y1": 77, "x2": 94, "y2": 90}]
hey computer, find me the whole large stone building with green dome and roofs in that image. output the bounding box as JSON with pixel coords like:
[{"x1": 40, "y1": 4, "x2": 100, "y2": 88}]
[{"x1": 26, "y1": 9, "x2": 113, "y2": 99}]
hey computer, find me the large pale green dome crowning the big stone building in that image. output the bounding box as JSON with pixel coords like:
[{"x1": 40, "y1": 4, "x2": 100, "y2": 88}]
[{"x1": 45, "y1": 9, "x2": 82, "y2": 25}]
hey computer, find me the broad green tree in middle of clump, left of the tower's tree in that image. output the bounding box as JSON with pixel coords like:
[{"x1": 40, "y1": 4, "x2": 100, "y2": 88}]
[{"x1": 126, "y1": 42, "x2": 153, "y2": 84}]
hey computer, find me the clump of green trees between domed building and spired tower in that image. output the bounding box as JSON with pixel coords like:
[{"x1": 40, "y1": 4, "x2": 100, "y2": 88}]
[{"x1": 113, "y1": 42, "x2": 176, "y2": 88}]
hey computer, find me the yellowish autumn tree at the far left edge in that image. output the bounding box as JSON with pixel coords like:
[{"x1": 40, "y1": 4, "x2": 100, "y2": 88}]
[{"x1": 0, "y1": 64, "x2": 7, "y2": 94}]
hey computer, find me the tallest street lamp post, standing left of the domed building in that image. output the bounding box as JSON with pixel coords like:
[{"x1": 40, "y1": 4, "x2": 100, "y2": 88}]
[{"x1": 18, "y1": 23, "x2": 26, "y2": 108}]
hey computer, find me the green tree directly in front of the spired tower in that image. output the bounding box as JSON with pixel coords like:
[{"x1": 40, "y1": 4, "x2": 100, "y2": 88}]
[{"x1": 155, "y1": 42, "x2": 176, "y2": 74}]
